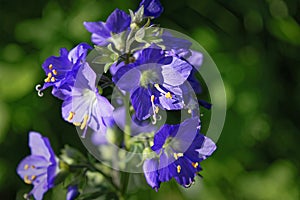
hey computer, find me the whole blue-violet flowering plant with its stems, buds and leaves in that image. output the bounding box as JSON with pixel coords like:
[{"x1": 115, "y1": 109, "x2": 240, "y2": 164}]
[{"x1": 17, "y1": 0, "x2": 220, "y2": 200}]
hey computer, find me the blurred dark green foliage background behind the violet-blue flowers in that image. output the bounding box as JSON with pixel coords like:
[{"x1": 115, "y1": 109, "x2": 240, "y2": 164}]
[{"x1": 0, "y1": 0, "x2": 300, "y2": 200}]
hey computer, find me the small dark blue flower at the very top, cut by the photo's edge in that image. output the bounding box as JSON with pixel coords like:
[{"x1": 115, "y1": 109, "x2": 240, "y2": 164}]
[{"x1": 140, "y1": 0, "x2": 164, "y2": 18}]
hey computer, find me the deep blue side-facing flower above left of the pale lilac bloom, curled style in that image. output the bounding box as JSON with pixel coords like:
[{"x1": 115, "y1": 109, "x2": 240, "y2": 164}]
[{"x1": 39, "y1": 43, "x2": 91, "y2": 100}]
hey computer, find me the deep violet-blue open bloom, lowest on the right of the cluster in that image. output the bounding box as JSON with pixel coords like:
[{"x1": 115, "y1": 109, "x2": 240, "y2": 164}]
[{"x1": 143, "y1": 118, "x2": 216, "y2": 190}]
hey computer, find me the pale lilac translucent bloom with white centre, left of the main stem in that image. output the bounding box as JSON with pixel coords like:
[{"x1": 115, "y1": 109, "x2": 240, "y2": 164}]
[{"x1": 62, "y1": 62, "x2": 114, "y2": 137}]
